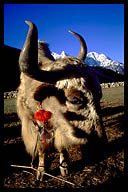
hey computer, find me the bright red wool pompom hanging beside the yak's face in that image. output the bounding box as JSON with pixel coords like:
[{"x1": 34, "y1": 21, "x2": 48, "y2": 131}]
[{"x1": 34, "y1": 110, "x2": 52, "y2": 122}]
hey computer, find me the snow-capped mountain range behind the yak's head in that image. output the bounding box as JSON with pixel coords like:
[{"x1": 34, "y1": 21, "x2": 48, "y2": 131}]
[{"x1": 52, "y1": 51, "x2": 124, "y2": 75}]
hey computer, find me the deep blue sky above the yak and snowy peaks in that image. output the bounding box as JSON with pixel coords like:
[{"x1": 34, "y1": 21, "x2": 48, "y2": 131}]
[{"x1": 4, "y1": 4, "x2": 124, "y2": 63}]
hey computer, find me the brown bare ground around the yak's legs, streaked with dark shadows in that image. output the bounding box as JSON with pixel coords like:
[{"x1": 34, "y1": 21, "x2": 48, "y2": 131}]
[{"x1": 3, "y1": 87, "x2": 124, "y2": 192}]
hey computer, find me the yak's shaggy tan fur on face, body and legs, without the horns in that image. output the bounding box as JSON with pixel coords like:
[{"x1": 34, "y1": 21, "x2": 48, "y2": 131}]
[{"x1": 17, "y1": 41, "x2": 106, "y2": 179}]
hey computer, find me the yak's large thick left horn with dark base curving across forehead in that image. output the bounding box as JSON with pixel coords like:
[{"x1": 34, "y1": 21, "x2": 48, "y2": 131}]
[{"x1": 19, "y1": 21, "x2": 66, "y2": 83}]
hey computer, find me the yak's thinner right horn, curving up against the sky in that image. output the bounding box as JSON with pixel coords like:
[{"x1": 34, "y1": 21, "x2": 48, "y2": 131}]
[{"x1": 68, "y1": 30, "x2": 87, "y2": 61}]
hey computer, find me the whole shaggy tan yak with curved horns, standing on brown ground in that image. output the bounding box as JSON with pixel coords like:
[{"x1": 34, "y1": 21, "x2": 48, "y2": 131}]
[{"x1": 17, "y1": 21, "x2": 107, "y2": 180}]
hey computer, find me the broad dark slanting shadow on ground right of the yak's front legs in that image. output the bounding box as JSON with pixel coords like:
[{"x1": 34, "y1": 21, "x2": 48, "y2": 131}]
[{"x1": 71, "y1": 137, "x2": 125, "y2": 172}]
